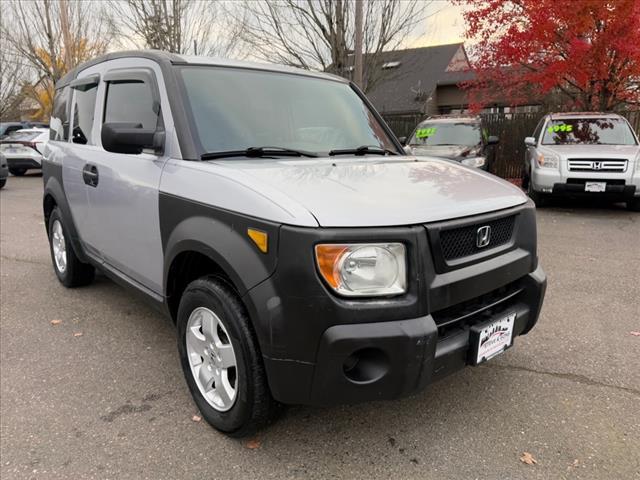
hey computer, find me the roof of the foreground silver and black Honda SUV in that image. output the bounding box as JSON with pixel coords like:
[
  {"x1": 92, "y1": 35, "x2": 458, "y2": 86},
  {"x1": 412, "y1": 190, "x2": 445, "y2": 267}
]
[{"x1": 56, "y1": 50, "x2": 349, "y2": 88}]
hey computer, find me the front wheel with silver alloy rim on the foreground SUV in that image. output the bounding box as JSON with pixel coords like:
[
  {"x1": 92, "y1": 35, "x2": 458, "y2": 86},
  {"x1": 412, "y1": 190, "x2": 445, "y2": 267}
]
[{"x1": 177, "y1": 277, "x2": 280, "y2": 437}]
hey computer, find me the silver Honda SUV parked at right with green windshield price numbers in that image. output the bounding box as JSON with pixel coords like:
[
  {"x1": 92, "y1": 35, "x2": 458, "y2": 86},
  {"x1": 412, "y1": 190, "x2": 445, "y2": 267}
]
[{"x1": 523, "y1": 112, "x2": 640, "y2": 211}]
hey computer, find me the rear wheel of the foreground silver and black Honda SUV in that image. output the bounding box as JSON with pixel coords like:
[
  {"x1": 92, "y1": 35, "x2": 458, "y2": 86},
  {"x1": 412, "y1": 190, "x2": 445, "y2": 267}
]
[{"x1": 49, "y1": 207, "x2": 95, "y2": 288}]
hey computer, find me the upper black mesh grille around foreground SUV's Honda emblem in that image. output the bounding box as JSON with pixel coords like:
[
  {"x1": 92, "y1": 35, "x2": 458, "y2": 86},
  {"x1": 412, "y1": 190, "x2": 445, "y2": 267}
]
[{"x1": 440, "y1": 215, "x2": 516, "y2": 261}]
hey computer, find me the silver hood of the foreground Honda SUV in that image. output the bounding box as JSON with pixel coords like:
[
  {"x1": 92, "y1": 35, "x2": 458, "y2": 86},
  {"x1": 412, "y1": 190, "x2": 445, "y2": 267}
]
[{"x1": 207, "y1": 156, "x2": 527, "y2": 227}]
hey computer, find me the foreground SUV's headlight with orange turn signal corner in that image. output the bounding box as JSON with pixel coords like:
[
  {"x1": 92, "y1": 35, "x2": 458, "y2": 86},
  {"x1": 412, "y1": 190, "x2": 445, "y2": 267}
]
[{"x1": 316, "y1": 243, "x2": 407, "y2": 297}]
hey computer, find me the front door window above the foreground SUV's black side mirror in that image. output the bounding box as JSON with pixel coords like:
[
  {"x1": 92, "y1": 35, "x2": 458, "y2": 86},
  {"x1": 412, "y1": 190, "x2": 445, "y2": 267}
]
[{"x1": 104, "y1": 82, "x2": 158, "y2": 129}]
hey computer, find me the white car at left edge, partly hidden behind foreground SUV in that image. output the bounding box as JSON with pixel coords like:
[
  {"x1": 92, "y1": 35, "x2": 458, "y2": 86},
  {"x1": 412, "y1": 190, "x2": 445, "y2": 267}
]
[{"x1": 0, "y1": 128, "x2": 49, "y2": 176}]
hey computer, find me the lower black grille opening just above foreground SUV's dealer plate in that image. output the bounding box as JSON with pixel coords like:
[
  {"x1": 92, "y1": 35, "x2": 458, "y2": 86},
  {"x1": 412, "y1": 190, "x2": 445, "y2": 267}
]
[{"x1": 431, "y1": 280, "x2": 524, "y2": 338}]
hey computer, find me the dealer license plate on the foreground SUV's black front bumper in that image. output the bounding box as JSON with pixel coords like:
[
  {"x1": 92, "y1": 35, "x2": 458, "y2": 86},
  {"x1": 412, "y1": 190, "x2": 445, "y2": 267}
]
[{"x1": 469, "y1": 312, "x2": 516, "y2": 365}]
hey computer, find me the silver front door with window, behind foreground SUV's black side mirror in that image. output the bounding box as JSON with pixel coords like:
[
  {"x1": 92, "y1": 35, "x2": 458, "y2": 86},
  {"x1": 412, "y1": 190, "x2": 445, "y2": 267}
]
[{"x1": 84, "y1": 58, "x2": 171, "y2": 293}]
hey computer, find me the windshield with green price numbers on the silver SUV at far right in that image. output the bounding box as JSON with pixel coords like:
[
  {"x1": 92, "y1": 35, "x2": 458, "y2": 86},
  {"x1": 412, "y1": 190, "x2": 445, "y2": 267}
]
[{"x1": 542, "y1": 118, "x2": 636, "y2": 145}]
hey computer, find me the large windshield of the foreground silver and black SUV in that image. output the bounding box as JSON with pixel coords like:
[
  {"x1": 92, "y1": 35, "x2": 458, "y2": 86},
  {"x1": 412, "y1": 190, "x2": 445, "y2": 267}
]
[{"x1": 180, "y1": 66, "x2": 396, "y2": 155}]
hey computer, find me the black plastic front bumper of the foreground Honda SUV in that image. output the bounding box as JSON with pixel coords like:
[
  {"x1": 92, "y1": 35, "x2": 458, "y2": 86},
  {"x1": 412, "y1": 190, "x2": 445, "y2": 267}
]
[{"x1": 265, "y1": 268, "x2": 546, "y2": 405}]
